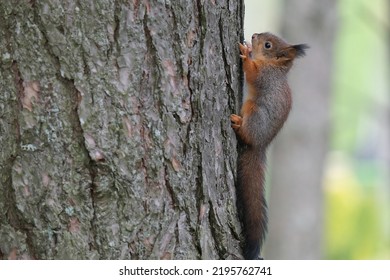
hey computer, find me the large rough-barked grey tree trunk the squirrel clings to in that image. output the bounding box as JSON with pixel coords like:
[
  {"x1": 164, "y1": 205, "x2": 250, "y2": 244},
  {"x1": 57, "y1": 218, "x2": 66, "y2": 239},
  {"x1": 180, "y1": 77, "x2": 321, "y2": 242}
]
[{"x1": 0, "y1": 0, "x2": 243, "y2": 259}]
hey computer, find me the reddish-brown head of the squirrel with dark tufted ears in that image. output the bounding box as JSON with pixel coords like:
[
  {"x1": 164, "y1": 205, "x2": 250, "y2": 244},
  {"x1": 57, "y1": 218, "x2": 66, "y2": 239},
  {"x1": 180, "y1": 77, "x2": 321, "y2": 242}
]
[{"x1": 252, "y1": 32, "x2": 309, "y2": 65}]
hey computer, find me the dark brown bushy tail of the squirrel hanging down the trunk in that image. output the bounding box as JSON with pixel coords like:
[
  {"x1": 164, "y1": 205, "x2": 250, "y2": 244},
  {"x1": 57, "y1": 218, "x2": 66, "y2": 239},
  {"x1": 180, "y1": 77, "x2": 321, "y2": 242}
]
[{"x1": 237, "y1": 147, "x2": 268, "y2": 260}]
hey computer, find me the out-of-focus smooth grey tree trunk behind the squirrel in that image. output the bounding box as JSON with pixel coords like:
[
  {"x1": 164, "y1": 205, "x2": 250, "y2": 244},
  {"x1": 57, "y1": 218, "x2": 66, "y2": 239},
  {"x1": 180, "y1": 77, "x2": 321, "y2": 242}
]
[{"x1": 265, "y1": 0, "x2": 337, "y2": 259}]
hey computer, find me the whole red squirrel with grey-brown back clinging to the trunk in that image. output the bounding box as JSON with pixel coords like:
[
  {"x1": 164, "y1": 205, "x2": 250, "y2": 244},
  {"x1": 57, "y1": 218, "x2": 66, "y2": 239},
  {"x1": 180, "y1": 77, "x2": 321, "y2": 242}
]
[{"x1": 230, "y1": 32, "x2": 309, "y2": 259}]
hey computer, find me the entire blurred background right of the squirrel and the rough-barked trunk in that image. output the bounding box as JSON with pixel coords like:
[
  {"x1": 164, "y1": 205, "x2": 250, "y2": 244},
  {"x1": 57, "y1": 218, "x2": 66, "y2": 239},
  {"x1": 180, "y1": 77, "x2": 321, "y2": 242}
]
[{"x1": 245, "y1": 0, "x2": 390, "y2": 259}]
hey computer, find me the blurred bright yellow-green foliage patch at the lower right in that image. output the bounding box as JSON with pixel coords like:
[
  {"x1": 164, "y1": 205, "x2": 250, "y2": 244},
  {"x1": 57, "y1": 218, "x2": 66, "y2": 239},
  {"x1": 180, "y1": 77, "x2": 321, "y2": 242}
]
[{"x1": 325, "y1": 159, "x2": 389, "y2": 259}]
